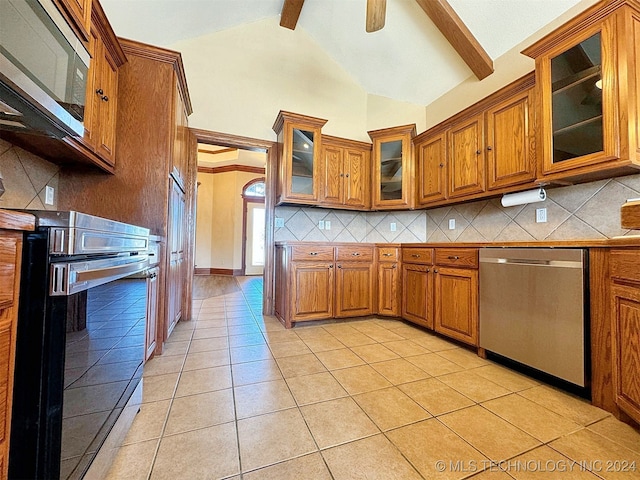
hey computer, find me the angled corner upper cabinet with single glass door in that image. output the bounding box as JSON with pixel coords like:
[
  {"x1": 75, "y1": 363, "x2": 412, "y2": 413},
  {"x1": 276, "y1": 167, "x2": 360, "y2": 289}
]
[{"x1": 368, "y1": 124, "x2": 416, "y2": 210}]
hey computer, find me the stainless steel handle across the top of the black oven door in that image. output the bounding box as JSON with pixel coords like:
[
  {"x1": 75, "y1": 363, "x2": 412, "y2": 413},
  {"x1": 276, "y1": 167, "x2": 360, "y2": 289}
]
[{"x1": 49, "y1": 255, "x2": 149, "y2": 296}]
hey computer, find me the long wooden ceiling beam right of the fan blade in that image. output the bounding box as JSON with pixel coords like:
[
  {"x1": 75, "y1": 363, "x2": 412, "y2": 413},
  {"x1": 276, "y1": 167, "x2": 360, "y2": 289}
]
[{"x1": 416, "y1": 0, "x2": 493, "y2": 80}]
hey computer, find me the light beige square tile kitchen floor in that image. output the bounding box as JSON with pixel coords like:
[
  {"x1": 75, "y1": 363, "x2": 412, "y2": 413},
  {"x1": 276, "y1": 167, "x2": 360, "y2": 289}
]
[{"x1": 109, "y1": 279, "x2": 640, "y2": 480}]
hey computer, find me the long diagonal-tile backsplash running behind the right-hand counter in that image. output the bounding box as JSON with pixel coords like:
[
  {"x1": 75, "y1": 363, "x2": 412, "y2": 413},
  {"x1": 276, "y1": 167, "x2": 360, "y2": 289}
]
[{"x1": 275, "y1": 174, "x2": 640, "y2": 243}]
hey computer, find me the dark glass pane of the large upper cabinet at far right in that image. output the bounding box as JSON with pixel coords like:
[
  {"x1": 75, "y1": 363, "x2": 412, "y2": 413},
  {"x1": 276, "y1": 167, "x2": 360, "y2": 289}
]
[{"x1": 551, "y1": 32, "x2": 604, "y2": 163}]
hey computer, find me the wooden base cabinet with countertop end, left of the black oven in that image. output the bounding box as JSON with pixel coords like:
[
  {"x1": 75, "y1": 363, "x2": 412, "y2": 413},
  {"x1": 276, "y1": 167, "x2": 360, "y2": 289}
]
[{"x1": 0, "y1": 210, "x2": 35, "y2": 479}]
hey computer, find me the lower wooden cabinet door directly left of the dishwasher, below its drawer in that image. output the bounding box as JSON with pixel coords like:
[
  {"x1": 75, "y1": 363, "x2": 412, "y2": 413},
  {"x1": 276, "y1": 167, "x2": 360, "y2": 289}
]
[{"x1": 433, "y1": 267, "x2": 478, "y2": 346}]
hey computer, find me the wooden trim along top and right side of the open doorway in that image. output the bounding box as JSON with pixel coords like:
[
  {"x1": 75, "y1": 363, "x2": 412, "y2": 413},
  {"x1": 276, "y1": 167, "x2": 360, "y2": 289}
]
[{"x1": 189, "y1": 128, "x2": 278, "y2": 315}]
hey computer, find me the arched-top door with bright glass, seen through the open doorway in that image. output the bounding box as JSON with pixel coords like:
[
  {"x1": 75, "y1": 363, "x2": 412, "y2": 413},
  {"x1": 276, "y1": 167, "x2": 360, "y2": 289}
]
[{"x1": 242, "y1": 178, "x2": 266, "y2": 275}]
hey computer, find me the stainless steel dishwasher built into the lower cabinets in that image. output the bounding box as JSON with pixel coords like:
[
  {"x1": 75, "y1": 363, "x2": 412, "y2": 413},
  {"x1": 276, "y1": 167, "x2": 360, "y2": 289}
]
[{"x1": 479, "y1": 248, "x2": 588, "y2": 387}]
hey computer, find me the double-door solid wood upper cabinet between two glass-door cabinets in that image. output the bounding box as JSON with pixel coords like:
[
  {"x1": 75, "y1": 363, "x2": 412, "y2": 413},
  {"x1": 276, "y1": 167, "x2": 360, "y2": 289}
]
[{"x1": 320, "y1": 135, "x2": 371, "y2": 210}]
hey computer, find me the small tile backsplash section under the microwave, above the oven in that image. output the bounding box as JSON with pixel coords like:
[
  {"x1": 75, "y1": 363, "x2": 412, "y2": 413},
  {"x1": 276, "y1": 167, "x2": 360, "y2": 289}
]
[{"x1": 0, "y1": 139, "x2": 60, "y2": 210}]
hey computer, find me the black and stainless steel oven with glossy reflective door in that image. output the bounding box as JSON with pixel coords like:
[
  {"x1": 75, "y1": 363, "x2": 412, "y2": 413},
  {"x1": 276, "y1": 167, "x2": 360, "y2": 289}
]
[{"x1": 9, "y1": 212, "x2": 149, "y2": 479}]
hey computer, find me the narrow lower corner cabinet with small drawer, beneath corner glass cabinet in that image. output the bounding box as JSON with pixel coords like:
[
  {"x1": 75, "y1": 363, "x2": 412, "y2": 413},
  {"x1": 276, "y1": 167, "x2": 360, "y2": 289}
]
[{"x1": 376, "y1": 246, "x2": 402, "y2": 317}]
